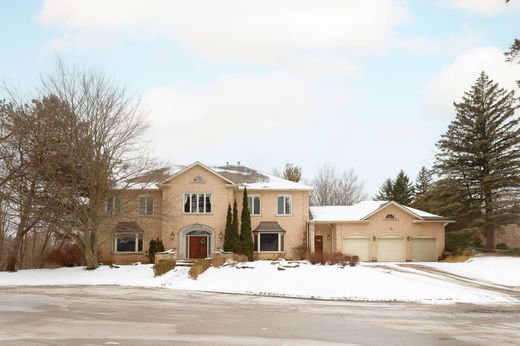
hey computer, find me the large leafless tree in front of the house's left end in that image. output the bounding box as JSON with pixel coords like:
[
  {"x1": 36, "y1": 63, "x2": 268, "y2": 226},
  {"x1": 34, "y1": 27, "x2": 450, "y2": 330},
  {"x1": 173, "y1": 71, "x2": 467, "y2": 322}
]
[{"x1": 38, "y1": 61, "x2": 157, "y2": 269}]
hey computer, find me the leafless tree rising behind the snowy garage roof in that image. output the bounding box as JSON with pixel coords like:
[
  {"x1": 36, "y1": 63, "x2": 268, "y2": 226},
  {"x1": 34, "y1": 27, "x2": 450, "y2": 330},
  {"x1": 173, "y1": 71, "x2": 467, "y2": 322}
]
[{"x1": 308, "y1": 165, "x2": 368, "y2": 205}]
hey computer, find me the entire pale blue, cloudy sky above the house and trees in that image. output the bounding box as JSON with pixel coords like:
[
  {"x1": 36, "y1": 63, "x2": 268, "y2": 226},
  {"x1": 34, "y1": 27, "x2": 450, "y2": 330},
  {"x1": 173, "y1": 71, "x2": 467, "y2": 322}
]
[{"x1": 0, "y1": 0, "x2": 520, "y2": 195}]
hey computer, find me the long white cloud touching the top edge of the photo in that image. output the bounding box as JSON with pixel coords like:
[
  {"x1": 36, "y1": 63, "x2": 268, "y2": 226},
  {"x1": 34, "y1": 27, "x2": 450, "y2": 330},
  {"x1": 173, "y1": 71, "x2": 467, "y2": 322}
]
[{"x1": 38, "y1": 0, "x2": 410, "y2": 64}]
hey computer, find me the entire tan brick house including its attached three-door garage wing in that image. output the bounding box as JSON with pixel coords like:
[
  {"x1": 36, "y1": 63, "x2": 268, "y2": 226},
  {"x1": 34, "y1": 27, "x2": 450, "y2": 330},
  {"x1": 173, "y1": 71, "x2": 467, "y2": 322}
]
[{"x1": 99, "y1": 162, "x2": 448, "y2": 264}]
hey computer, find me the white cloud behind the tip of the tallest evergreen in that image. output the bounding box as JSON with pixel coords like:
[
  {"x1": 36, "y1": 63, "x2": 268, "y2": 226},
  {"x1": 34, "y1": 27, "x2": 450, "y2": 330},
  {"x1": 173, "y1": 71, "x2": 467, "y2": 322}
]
[{"x1": 426, "y1": 47, "x2": 520, "y2": 114}]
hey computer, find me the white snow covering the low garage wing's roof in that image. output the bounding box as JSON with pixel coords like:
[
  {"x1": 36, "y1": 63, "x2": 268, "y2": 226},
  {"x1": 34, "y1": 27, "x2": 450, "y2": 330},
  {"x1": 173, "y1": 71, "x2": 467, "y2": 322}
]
[{"x1": 310, "y1": 201, "x2": 444, "y2": 222}]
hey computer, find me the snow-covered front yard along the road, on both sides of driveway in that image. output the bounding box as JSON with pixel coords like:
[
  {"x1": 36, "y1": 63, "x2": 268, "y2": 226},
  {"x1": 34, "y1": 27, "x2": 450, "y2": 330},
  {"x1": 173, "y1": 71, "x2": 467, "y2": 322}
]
[{"x1": 0, "y1": 257, "x2": 520, "y2": 303}]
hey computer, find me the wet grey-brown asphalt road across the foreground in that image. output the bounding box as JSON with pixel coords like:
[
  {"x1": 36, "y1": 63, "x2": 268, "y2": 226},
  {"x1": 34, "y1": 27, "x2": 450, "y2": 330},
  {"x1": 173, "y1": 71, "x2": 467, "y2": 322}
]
[{"x1": 0, "y1": 286, "x2": 520, "y2": 346}]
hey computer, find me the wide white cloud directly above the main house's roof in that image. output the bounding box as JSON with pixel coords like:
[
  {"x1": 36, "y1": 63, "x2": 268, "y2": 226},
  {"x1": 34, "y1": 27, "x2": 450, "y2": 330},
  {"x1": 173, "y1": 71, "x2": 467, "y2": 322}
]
[{"x1": 143, "y1": 72, "x2": 349, "y2": 154}]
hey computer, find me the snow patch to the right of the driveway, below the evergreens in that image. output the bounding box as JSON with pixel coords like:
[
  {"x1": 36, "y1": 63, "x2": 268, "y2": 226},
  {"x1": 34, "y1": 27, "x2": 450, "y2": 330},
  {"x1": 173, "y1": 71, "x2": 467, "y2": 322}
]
[{"x1": 425, "y1": 256, "x2": 520, "y2": 290}]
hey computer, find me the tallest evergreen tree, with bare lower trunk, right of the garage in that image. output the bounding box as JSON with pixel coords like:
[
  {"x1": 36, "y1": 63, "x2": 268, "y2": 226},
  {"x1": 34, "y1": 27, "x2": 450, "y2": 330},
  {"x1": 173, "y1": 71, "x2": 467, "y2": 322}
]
[{"x1": 436, "y1": 72, "x2": 520, "y2": 248}]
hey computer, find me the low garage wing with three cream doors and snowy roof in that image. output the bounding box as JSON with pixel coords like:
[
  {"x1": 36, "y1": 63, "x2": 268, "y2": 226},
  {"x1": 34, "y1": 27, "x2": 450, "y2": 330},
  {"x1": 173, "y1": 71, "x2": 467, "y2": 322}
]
[{"x1": 309, "y1": 201, "x2": 451, "y2": 262}]
